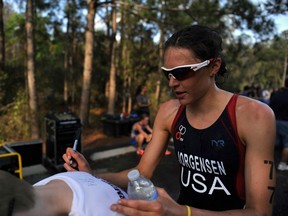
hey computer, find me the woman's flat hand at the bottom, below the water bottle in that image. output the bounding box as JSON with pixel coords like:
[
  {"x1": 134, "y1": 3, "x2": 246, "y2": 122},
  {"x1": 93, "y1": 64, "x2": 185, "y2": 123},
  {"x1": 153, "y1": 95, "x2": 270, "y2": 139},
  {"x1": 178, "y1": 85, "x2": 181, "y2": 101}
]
[{"x1": 111, "y1": 188, "x2": 187, "y2": 216}]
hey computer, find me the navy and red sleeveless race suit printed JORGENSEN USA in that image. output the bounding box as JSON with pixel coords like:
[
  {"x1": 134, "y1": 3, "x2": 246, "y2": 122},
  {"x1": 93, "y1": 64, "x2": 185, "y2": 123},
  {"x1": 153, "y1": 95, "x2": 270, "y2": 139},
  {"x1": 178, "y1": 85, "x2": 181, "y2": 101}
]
[{"x1": 172, "y1": 94, "x2": 245, "y2": 211}]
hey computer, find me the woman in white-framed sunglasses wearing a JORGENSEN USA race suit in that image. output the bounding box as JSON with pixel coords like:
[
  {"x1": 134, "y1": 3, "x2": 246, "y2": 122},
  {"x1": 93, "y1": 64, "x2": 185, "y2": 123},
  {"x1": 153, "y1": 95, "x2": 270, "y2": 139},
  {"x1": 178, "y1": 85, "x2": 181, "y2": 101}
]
[{"x1": 63, "y1": 25, "x2": 275, "y2": 216}]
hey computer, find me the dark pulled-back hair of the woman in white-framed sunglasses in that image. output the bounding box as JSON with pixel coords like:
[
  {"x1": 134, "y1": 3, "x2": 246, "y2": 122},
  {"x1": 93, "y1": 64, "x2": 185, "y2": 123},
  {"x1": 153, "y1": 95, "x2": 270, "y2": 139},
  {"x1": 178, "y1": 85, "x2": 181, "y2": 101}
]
[{"x1": 164, "y1": 25, "x2": 227, "y2": 76}]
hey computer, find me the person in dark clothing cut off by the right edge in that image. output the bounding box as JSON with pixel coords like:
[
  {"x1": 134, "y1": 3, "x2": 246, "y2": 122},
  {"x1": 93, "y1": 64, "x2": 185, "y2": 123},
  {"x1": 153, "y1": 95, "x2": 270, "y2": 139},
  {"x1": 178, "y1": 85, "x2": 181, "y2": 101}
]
[{"x1": 270, "y1": 78, "x2": 288, "y2": 171}]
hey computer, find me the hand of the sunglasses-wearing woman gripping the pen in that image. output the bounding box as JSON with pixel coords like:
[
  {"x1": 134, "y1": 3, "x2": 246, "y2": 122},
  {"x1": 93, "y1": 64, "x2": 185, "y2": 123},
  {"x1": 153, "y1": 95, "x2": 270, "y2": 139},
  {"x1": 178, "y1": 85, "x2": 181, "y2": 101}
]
[{"x1": 62, "y1": 147, "x2": 92, "y2": 173}]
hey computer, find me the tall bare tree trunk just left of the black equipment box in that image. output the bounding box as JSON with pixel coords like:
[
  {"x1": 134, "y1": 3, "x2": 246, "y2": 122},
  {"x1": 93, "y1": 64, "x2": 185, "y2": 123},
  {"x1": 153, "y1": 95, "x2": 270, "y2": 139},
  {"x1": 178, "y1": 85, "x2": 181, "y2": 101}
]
[{"x1": 26, "y1": 0, "x2": 40, "y2": 139}]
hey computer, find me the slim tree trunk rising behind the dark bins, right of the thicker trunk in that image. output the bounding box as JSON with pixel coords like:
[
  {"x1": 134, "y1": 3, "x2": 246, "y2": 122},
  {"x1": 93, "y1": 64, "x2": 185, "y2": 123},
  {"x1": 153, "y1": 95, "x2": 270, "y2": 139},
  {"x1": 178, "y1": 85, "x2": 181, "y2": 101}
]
[{"x1": 108, "y1": 1, "x2": 117, "y2": 115}]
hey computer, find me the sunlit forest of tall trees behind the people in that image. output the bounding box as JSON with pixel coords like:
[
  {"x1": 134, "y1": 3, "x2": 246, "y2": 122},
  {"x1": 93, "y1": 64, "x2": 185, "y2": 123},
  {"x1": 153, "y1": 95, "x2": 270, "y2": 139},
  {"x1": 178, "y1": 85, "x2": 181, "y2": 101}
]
[{"x1": 0, "y1": 0, "x2": 288, "y2": 143}]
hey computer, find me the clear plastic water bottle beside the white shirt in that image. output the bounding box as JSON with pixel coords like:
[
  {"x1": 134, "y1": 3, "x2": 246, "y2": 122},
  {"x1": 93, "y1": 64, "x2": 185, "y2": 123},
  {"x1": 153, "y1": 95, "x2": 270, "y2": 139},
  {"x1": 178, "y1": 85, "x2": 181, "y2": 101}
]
[{"x1": 127, "y1": 169, "x2": 158, "y2": 200}]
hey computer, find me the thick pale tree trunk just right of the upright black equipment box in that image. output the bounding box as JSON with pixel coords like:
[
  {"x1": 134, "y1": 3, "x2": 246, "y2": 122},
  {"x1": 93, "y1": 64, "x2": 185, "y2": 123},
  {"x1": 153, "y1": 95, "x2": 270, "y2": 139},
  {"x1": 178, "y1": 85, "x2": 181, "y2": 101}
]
[{"x1": 80, "y1": 0, "x2": 96, "y2": 126}]
